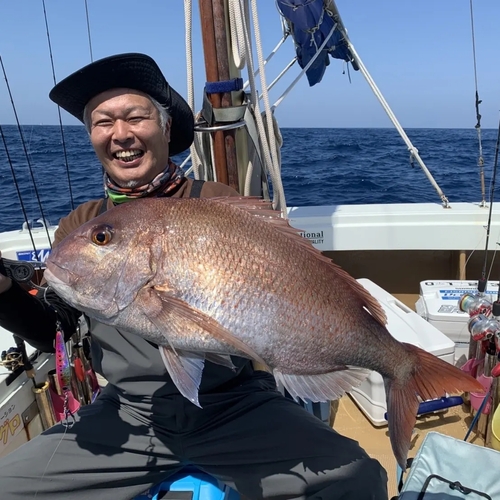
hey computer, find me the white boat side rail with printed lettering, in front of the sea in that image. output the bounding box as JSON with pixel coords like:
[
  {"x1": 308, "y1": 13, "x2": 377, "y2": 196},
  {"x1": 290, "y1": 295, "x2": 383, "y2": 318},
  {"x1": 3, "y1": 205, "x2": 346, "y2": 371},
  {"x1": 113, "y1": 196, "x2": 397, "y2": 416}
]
[{"x1": 288, "y1": 203, "x2": 500, "y2": 251}]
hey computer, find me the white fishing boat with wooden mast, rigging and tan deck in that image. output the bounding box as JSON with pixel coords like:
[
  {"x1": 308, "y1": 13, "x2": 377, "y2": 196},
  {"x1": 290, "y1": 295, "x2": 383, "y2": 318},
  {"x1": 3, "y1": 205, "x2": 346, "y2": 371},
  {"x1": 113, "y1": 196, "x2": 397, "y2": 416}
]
[{"x1": 0, "y1": 0, "x2": 500, "y2": 495}]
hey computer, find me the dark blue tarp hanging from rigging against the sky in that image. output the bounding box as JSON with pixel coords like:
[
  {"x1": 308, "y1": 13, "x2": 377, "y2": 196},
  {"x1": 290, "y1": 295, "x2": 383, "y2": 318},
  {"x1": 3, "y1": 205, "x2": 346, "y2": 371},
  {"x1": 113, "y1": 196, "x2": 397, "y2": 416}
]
[{"x1": 277, "y1": 0, "x2": 358, "y2": 87}]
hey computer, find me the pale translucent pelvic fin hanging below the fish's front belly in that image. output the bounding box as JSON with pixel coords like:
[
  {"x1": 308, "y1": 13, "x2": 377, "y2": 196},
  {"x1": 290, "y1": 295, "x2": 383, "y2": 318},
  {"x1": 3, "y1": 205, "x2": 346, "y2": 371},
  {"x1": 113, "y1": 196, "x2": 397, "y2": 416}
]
[{"x1": 158, "y1": 346, "x2": 205, "y2": 408}]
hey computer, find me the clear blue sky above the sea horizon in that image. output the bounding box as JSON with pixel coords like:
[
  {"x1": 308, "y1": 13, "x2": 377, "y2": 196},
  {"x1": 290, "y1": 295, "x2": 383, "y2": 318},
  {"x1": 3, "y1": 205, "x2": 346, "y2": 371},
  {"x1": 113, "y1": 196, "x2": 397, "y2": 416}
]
[{"x1": 0, "y1": 0, "x2": 500, "y2": 128}]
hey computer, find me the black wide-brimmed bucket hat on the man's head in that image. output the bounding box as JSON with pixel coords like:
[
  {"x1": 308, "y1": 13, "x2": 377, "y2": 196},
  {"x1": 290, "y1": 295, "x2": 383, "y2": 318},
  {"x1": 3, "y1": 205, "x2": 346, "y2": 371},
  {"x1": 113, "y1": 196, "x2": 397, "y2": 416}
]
[{"x1": 49, "y1": 53, "x2": 194, "y2": 156}]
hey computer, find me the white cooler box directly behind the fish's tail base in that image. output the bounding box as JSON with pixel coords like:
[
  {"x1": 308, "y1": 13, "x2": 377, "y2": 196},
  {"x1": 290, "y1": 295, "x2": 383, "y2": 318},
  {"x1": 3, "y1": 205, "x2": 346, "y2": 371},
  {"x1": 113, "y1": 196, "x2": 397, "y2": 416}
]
[{"x1": 350, "y1": 278, "x2": 455, "y2": 426}]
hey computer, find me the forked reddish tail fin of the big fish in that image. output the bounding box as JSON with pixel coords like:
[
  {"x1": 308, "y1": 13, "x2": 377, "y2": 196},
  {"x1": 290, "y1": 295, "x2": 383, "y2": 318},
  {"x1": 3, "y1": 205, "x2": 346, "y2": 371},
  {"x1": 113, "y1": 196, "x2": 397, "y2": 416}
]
[{"x1": 384, "y1": 343, "x2": 484, "y2": 470}]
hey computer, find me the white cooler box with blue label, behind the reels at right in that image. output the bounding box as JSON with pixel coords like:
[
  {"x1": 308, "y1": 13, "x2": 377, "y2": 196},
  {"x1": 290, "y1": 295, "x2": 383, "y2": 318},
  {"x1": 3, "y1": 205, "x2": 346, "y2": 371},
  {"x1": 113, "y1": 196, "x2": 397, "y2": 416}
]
[{"x1": 415, "y1": 280, "x2": 498, "y2": 366}]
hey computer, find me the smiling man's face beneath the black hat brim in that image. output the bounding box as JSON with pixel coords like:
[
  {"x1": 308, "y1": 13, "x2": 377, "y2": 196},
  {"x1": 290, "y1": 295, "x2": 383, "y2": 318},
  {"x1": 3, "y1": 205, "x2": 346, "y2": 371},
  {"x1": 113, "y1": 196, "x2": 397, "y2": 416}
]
[{"x1": 87, "y1": 89, "x2": 170, "y2": 187}]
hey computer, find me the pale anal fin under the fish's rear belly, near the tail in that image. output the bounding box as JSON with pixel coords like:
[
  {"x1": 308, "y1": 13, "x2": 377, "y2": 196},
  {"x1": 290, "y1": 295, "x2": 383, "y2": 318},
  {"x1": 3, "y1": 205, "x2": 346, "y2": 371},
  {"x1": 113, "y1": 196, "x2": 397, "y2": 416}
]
[{"x1": 274, "y1": 366, "x2": 370, "y2": 403}]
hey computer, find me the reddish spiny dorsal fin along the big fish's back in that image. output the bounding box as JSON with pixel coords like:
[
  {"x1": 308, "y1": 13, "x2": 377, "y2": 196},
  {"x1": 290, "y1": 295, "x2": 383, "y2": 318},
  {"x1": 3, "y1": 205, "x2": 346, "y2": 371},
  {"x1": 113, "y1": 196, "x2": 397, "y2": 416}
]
[{"x1": 212, "y1": 196, "x2": 387, "y2": 326}]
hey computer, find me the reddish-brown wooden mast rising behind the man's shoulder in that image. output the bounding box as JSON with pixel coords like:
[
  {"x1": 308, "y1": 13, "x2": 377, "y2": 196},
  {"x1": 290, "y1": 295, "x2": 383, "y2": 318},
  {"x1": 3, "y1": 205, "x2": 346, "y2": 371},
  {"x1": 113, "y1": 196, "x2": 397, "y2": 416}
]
[{"x1": 199, "y1": 0, "x2": 239, "y2": 191}]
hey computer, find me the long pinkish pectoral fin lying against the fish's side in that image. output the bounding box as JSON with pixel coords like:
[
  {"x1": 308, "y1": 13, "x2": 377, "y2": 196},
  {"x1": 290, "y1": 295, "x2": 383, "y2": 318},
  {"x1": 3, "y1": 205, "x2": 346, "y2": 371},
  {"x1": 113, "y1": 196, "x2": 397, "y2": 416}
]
[{"x1": 155, "y1": 291, "x2": 267, "y2": 366}]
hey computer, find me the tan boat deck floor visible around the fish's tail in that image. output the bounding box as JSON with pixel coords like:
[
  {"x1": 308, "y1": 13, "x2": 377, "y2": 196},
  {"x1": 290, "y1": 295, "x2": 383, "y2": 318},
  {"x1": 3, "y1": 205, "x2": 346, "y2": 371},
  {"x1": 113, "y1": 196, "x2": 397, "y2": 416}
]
[{"x1": 333, "y1": 395, "x2": 484, "y2": 498}]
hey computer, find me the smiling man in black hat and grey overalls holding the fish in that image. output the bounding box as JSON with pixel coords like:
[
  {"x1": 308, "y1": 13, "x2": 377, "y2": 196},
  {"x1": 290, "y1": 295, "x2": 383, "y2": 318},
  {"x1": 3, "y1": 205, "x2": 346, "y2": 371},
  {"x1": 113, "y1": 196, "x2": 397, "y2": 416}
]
[{"x1": 0, "y1": 54, "x2": 387, "y2": 500}]
